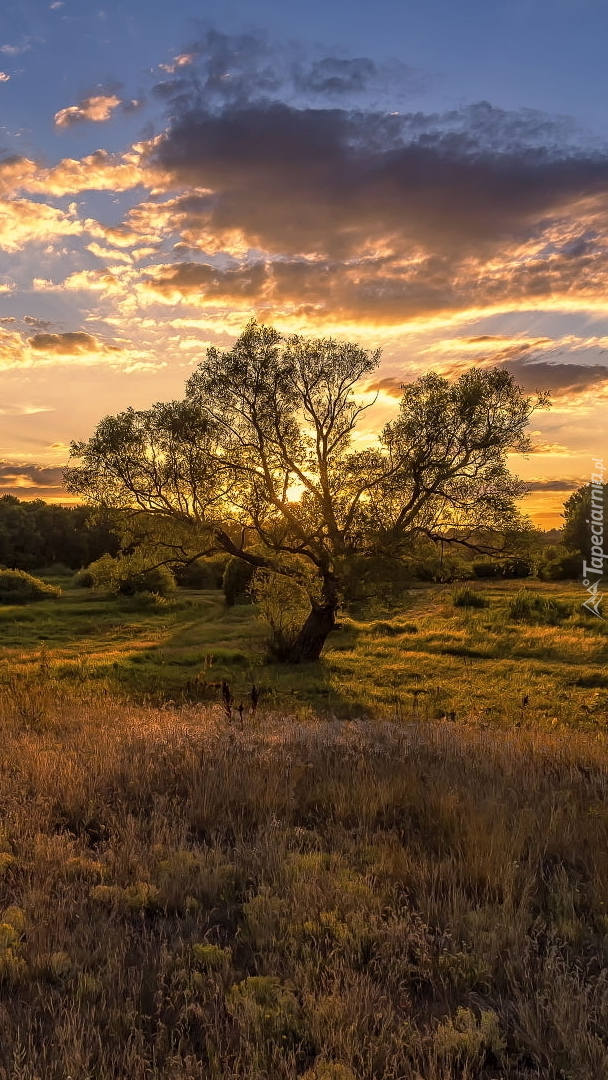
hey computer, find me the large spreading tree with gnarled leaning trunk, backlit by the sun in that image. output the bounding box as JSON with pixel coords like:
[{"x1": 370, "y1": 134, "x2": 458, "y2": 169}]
[{"x1": 65, "y1": 322, "x2": 546, "y2": 662}]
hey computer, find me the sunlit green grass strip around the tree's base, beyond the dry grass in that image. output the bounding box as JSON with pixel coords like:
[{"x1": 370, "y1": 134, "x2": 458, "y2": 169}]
[{"x1": 0, "y1": 581, "x2": 608, "y2": 726}]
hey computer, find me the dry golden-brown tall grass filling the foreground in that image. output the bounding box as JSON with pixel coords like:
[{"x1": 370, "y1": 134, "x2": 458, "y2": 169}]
[{"x1": 0, "y1": 681, "x2": 608, "y2": 1080}]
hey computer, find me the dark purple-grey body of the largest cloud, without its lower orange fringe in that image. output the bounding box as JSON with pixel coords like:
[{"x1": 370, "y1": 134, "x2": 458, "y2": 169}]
[{"x1": 152, "y1": 88, "x2": 608, "y2": 270}]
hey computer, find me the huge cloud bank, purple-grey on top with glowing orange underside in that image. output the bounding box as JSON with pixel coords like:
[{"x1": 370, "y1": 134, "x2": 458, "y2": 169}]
[{"x1": 123, "y1": 31, "x2": 608, "y2": 326}]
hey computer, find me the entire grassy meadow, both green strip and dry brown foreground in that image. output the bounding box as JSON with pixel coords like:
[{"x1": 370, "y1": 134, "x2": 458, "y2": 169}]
[{"x1": 0, "y1": 579, "x2": 608, "y2": 1080}]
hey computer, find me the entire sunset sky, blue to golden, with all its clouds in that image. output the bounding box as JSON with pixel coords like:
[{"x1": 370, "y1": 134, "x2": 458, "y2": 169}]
[{"x1": 0, "y1": 0, "x2": 608, "y2": 528}]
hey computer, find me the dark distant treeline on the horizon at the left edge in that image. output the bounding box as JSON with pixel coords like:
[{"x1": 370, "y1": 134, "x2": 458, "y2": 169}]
[{"x1": 0, "y1": 495, "x2": 120, "y2": 570}]
